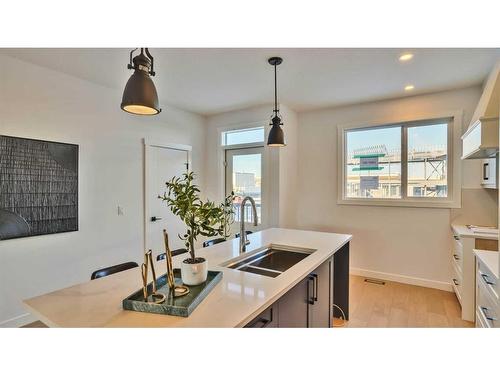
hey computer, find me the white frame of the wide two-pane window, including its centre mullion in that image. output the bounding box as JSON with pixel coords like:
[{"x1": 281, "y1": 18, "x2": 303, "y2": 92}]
[{"x1": 337, "y1": 111, "x2": 462, "y2": 208}]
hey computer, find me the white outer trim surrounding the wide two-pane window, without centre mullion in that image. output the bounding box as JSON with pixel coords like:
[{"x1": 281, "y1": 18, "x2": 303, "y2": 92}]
[{"x1": 337, "y1": 110, "x2": 463, "y2": 208}]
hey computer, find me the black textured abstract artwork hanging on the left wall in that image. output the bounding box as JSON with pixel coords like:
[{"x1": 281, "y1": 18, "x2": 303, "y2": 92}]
[{"x1": 0, "y1": 136, "x2": 78, "y2": 240}]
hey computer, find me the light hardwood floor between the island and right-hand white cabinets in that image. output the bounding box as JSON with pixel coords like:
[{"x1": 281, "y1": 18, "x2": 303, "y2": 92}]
[{"x1": 335, "y1": 275, "x2": 474, "y2": 328}]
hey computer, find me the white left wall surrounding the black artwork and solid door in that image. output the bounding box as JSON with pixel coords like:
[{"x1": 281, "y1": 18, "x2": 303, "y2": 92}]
[{"x1": 0, "y1": 55, "x2": 205, "y2": 326}]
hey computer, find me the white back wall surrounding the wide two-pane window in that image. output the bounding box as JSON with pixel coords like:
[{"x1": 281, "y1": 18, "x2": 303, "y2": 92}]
[{"x1": 296, "y1": 87, "x2": 497, "y2": 288}]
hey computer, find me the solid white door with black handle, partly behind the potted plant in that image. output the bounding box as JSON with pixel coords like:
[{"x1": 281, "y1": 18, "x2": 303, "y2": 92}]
[{"x1": 145, "y1": 145, "x2": 189, "y2": 256}]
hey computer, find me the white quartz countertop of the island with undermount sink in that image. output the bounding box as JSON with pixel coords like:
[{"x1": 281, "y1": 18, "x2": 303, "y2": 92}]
[{"x1": 23, "y1": 228, "x2": 352, "y2": 327}]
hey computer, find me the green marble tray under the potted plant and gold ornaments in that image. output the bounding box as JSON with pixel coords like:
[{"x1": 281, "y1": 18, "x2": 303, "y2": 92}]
[{"x1": 123, "y1": 268, "x2": 222, "y2": 317}]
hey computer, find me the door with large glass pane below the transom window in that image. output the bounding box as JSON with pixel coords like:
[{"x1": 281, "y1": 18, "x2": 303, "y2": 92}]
[{"x1": 225, "y1": 147, "x2": 267, "y2": 234}]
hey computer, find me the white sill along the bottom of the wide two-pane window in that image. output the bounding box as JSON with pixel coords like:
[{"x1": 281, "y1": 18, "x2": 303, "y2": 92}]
[{"x1": 337, "y1": 198, "x2": 461, "y2": 208}]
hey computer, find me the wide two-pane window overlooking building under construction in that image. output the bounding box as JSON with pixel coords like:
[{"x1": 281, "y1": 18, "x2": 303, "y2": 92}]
[{"x1": 339, "y1": 118, "x2": 453, "y2": 205}]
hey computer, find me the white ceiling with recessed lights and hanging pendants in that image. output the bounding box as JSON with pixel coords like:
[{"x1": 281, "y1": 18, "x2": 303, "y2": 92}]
[{"x1": 0, "y1": 48, "x2": 500, "y2": 115}]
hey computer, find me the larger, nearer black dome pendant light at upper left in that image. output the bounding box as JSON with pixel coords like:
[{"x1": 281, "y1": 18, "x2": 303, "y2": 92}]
[{"x1": 121, "y1": 48, "x2": 161, "y2": 115}]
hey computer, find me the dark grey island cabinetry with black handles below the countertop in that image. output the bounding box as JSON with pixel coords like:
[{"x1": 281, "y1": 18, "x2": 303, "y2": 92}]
[{"x1": 245, "y1": 243, "x2": 349, "y2": 328}]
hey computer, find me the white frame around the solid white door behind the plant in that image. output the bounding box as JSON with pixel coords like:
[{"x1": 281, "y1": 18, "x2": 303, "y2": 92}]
[{"x1": 142, "y1": 138, "x2": 193, "y2": 252}]
